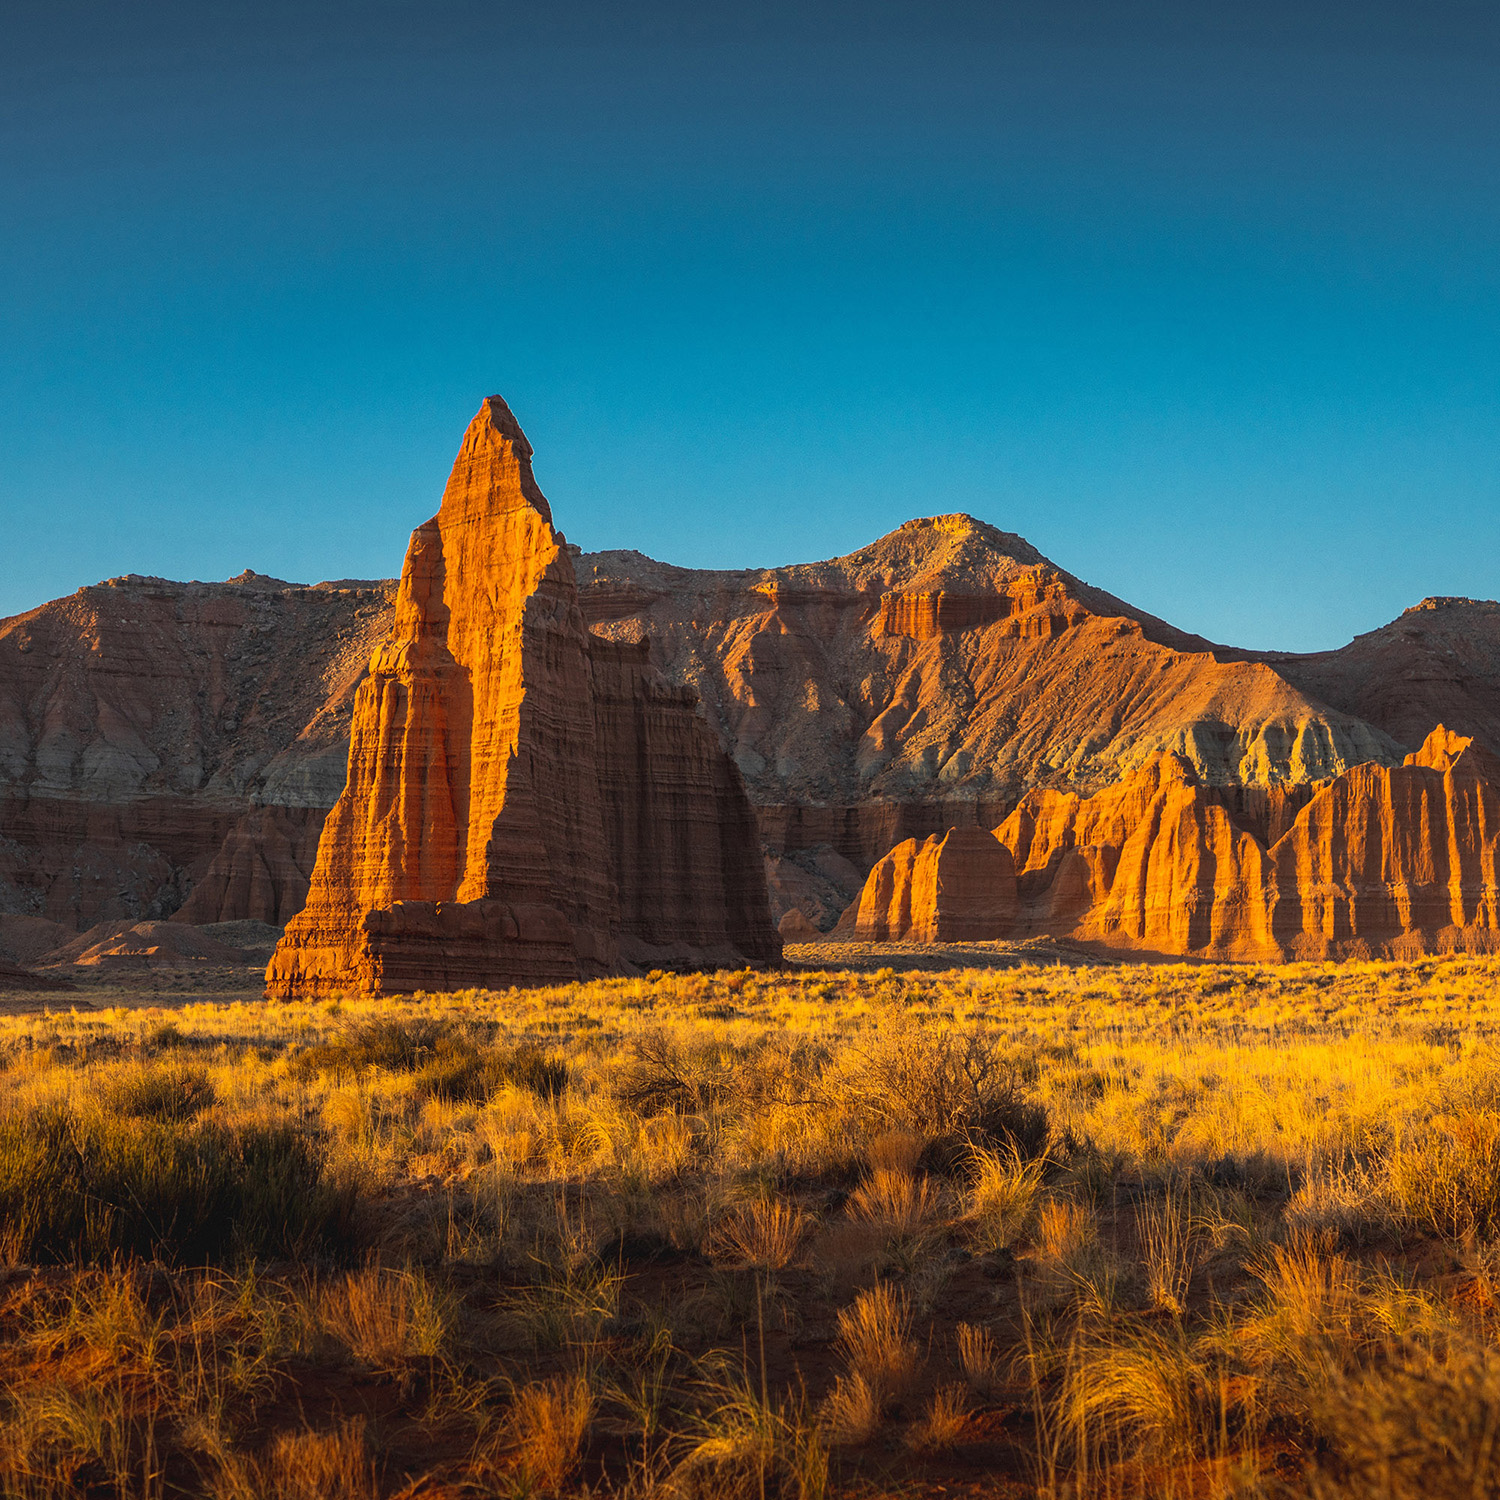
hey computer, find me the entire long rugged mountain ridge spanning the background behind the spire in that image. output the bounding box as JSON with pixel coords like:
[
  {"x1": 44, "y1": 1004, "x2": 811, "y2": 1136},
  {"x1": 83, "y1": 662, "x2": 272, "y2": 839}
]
[{"x1": 0, "y1": 444, "x2": 1500, "y2": 951}]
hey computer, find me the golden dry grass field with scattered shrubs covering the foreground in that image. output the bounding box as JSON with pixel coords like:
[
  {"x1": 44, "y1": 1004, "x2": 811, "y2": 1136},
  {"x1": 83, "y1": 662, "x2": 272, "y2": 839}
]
[{"x1": 0, "y1": 956, "x2": 1500, "y2": 1500}]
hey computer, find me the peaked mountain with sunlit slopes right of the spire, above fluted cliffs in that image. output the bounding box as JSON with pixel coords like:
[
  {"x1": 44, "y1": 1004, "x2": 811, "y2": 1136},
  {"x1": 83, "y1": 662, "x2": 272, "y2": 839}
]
[{"x1": 581, "y1": 516, "x2": 1400, "y2": 840}]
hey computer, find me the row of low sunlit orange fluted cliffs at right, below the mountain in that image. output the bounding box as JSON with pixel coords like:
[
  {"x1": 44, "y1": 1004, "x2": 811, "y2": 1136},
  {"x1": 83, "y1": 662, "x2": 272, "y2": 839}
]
[{"x1": 839, "y1": 726, "x2": 1500, "y2": 962}]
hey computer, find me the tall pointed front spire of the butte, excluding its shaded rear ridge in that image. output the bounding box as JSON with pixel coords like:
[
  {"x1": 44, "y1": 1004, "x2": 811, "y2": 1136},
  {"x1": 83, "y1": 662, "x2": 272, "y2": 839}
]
[{"x1": 267, "y1": 396, "x2": 774, "y2": 995}]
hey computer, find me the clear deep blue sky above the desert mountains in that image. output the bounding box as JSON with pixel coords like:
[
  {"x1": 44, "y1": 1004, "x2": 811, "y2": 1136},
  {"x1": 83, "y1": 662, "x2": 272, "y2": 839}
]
[{"x1": 0, "y1": 0, "x2": 1500, "y2": 650}]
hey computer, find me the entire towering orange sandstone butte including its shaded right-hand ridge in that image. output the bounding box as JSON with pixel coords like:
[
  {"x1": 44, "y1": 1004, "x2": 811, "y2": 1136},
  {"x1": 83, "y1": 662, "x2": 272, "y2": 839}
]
[{"x1": 266, "y1": 396, "x2": 780, "y2": 996}]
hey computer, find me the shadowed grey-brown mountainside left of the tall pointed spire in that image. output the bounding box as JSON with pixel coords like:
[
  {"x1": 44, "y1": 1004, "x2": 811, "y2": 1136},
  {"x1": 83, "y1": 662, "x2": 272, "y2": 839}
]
[{"x1": 0, "y1": 573, "x2": 392, "y2": 930}]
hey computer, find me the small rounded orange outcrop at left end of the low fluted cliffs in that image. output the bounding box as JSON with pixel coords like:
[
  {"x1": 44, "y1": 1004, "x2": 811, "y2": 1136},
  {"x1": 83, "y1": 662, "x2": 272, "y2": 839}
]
[{"x1": 836, "y1": 828, "x2": 1017, "y2": 942}]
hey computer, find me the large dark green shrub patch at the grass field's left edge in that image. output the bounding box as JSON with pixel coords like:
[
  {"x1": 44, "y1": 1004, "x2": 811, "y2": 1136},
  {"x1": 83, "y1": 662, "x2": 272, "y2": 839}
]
[{"x1": 0, "y1": 1106, "x2": 353, "y2": 1265}]
